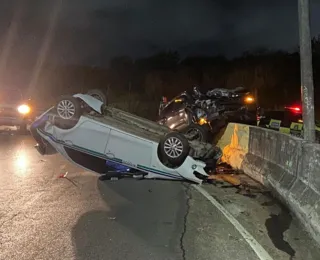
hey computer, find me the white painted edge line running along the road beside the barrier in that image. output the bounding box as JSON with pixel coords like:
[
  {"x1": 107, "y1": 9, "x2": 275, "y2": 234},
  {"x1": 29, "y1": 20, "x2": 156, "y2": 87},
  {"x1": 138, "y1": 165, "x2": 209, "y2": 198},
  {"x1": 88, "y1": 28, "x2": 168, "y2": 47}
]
[{"x1": 192, "y1": 184, "x2": 273, "y2": 260}]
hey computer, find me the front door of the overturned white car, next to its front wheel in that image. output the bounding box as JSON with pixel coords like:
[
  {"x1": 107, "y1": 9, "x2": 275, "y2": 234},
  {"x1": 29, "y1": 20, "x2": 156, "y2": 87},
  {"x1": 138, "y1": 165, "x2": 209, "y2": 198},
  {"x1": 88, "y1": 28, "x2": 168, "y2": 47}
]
[{"x1": 105, "y1": 129, "x2": 153, "y2": 167}]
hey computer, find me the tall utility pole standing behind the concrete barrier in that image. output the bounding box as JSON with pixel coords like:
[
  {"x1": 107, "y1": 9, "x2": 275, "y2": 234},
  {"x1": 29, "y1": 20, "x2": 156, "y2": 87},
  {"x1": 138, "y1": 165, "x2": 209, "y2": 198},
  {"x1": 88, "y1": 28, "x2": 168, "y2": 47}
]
[{"x1": 298, "y1": 0, "x2": 315, "y2": 142}]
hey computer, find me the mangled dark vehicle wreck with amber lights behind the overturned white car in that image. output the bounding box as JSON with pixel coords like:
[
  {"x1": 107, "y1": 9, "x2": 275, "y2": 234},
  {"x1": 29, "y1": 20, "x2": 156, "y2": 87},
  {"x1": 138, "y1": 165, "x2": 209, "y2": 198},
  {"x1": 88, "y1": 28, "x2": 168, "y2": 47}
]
[{"x1": 158, "y1": 87, "x2": 256, "y2": 141}]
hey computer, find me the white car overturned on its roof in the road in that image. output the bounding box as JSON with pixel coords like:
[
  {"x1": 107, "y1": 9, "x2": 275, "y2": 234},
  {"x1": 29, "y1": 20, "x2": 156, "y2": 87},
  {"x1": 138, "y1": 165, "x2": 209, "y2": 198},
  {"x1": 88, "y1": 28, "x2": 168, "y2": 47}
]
[{"x1": 30, "y1": 90, "x2": 219, "y2": 183}]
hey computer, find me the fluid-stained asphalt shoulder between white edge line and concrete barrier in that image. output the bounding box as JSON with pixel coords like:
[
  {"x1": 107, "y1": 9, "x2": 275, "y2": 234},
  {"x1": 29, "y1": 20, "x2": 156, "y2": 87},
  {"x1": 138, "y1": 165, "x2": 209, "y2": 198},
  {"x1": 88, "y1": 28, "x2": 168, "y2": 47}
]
[{"x1": 205, "y1": 175, "x2": 320, "y2": 260}]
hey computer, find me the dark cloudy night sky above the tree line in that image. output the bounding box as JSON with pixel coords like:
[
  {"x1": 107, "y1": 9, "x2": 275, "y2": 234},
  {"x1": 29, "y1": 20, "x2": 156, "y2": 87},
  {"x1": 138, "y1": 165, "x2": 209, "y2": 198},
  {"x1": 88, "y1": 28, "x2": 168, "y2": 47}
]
[{"x1": 0, "y1": 0, "x2": 320, "y2": 66}]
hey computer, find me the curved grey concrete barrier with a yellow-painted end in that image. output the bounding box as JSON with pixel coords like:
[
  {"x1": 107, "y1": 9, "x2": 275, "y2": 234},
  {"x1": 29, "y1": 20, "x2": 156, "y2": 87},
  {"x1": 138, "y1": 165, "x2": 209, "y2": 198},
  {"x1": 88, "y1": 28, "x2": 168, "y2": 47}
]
[{"x1": 217, "y1": 123, "x2": 320, "y2": 243}]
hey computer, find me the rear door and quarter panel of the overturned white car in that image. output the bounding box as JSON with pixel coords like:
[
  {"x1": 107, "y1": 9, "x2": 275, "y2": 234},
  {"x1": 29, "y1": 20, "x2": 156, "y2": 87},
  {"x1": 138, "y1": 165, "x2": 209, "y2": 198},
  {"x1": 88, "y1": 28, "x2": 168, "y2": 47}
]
[{"x1": 55, "y1": 117, "x2": 110, "y2": 156}]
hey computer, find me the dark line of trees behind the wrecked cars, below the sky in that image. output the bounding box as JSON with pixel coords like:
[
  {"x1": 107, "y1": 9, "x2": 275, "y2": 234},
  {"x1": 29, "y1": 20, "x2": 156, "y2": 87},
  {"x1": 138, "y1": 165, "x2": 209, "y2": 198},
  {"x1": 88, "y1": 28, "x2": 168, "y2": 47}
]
[{"x1": 30, "y1": 37, "x2": 320, "y2": 119}]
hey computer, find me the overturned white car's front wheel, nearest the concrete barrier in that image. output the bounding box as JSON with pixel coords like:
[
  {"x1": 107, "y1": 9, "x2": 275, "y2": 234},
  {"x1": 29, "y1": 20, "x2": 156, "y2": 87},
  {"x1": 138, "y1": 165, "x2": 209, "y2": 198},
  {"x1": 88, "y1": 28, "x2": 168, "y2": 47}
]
[{"x1": 159, "y1": 132, "x2": 190, "y2": 167}]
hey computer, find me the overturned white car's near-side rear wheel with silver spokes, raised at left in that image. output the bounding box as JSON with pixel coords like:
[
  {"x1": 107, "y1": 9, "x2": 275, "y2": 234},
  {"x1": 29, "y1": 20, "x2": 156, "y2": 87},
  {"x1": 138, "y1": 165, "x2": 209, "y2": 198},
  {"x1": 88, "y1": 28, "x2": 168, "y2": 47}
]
[{"x1": 54, "y1": 96, "x2": 82, "y2": 129}]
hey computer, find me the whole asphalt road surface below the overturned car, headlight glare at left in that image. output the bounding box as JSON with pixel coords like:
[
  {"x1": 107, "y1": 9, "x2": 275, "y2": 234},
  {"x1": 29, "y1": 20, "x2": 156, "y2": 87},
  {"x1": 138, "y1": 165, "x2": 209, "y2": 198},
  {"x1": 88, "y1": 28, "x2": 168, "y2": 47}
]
[{"x1": 0, "y1": 133, "x2": 320, "y2": 260}]
